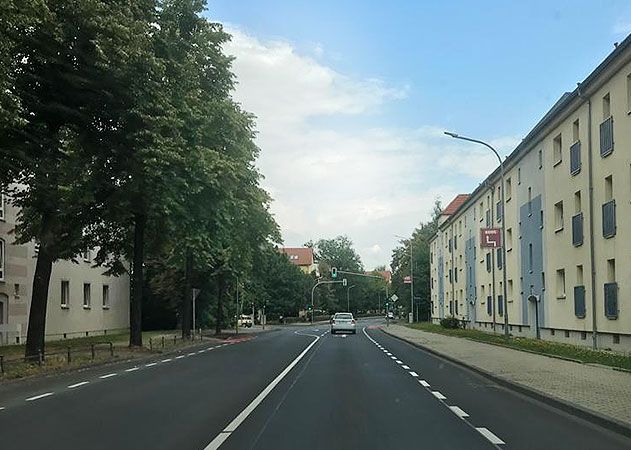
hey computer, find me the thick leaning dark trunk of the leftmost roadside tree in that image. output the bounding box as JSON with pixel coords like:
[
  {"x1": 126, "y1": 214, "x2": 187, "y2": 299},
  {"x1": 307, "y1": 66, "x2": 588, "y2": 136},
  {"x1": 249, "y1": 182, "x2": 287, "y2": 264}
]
[{"x1": 24, "y1": 243, "x2": 54, "y2": 358}]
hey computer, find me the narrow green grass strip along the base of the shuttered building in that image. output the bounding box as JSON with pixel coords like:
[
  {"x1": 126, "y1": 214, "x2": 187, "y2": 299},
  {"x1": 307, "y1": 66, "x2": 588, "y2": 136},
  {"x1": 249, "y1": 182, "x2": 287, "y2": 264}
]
[{"x1": 406, "y1": 323, "x2": 631, "y2": 370}]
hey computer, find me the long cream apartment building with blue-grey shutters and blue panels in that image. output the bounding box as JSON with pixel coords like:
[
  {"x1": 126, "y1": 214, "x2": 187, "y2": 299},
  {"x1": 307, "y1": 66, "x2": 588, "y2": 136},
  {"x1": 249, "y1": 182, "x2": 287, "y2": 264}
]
[{"x1": 430, "y1": 36, "x2": 631, "y2": 351}]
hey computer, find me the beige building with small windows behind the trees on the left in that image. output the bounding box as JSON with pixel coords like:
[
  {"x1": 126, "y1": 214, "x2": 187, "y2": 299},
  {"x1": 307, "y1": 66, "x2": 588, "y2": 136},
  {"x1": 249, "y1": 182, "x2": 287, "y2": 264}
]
[{"x1": 0, "y1": 197, "x2": 129, "y2": 345}]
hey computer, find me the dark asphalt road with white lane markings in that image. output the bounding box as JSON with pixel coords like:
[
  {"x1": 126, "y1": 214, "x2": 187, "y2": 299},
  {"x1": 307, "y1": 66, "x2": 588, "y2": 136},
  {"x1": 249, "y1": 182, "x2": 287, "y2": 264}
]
[{"x1": 0, "y1": 320, "x2": 631, "y2": 450}]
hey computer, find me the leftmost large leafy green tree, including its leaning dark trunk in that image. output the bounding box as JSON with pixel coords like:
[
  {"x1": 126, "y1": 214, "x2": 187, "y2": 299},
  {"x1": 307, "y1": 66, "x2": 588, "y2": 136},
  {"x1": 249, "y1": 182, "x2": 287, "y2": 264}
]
[{"x1": 0, "y1": 0, "x2": 160, "y2": 357}]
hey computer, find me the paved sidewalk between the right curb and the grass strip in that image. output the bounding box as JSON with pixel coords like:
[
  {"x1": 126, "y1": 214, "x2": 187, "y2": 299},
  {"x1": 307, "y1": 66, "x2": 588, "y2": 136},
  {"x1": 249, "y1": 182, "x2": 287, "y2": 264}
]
[{"x1": 382, "y1": 325, "x2": 631, "y2": 427}]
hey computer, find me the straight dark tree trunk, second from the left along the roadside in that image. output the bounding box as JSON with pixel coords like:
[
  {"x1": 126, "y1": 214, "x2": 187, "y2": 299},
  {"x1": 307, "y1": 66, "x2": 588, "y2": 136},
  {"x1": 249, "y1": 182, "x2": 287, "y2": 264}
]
[{"x1": 129, "y1": 214, "x2": 147, "y2": 347}]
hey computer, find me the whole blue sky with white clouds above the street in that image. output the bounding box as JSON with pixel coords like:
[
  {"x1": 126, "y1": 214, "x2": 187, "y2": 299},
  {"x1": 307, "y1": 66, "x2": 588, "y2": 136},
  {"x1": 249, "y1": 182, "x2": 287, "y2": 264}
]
[{"x1": 207, "y1": 0, "x2": 631, "y2": 269}]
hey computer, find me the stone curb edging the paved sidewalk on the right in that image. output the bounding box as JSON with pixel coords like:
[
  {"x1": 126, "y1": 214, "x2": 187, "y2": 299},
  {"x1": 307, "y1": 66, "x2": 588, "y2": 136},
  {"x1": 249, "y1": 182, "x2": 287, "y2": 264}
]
[{"x1": 381, "y1": 328, "x2": 631, "y2": 438}]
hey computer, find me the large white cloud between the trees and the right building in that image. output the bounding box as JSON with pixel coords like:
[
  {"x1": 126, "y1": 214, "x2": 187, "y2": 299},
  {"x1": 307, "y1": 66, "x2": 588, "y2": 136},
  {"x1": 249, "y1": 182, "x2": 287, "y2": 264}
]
[{"x1": 225, "y1": 27, "x2": 515, "y2": 268}]
